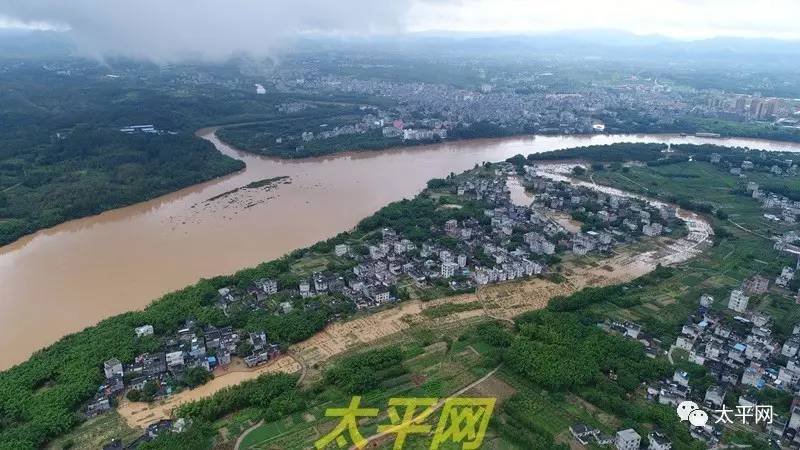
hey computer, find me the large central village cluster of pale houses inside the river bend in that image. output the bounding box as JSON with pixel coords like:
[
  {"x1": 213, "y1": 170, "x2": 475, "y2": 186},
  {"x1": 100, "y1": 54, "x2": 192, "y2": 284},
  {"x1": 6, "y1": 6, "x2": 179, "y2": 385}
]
[{"x1": 209, "y1": 163, "x2": 676, "y2": 314}]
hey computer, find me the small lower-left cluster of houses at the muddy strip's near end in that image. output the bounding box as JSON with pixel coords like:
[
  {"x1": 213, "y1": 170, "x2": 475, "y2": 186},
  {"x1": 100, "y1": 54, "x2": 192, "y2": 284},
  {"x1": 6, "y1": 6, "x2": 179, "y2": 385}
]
[{"x1": 86, "y1": 320, "x2": 281, "y2": 417}]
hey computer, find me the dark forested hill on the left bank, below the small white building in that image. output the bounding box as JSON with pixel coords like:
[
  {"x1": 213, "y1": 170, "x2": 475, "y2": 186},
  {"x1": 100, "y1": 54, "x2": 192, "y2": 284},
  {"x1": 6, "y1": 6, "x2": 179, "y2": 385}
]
[{"x1": 0, "y1": 126, "x2": 244, "y2": 245}]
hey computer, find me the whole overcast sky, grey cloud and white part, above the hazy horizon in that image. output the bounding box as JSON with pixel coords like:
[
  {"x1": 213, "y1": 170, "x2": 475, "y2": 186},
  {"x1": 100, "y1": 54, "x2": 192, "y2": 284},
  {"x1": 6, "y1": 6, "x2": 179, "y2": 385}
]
[{"x1": 0, "y1": 0, "x2": 800, "y2": 61}]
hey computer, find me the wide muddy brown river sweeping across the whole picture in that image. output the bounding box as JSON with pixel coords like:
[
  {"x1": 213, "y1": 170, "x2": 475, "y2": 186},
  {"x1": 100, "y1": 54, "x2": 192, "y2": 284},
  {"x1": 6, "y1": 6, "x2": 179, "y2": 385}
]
[{"x1": 0, "y1": 129, "x2": 800, "y2": 369}]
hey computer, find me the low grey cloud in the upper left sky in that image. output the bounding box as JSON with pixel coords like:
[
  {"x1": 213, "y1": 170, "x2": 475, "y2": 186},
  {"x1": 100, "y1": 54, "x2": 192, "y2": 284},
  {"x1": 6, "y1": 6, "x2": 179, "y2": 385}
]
[{"x1": 0, "y1": 0, "x2": 408, "y2": 62}]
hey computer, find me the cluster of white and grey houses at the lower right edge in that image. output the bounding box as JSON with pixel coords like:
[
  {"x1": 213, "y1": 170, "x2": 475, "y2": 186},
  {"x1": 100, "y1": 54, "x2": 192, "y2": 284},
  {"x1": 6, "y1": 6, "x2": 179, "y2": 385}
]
[{"x1": 636, "y1": 276, "x2": 800, "y2": 448}]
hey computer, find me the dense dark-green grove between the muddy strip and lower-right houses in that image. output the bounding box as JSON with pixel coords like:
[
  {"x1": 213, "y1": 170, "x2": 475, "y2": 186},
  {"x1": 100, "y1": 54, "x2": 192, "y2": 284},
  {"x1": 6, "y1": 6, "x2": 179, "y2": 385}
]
[{"x1": 497, "y1": 304, "x2": 704, "y2": 450}]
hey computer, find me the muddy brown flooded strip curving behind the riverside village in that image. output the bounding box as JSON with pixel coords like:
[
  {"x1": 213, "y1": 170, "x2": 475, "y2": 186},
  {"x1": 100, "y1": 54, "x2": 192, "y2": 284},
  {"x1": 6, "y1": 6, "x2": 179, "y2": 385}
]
[{"x1": 109, "y1": 170, "x2": 713, "y2": 428}]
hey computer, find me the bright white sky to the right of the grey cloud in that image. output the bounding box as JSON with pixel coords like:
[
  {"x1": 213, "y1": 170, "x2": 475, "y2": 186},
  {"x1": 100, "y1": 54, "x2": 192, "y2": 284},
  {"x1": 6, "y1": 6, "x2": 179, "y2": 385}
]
[{"x1": 407, "y1": 0, "x2": 800, "y2": 39}]
